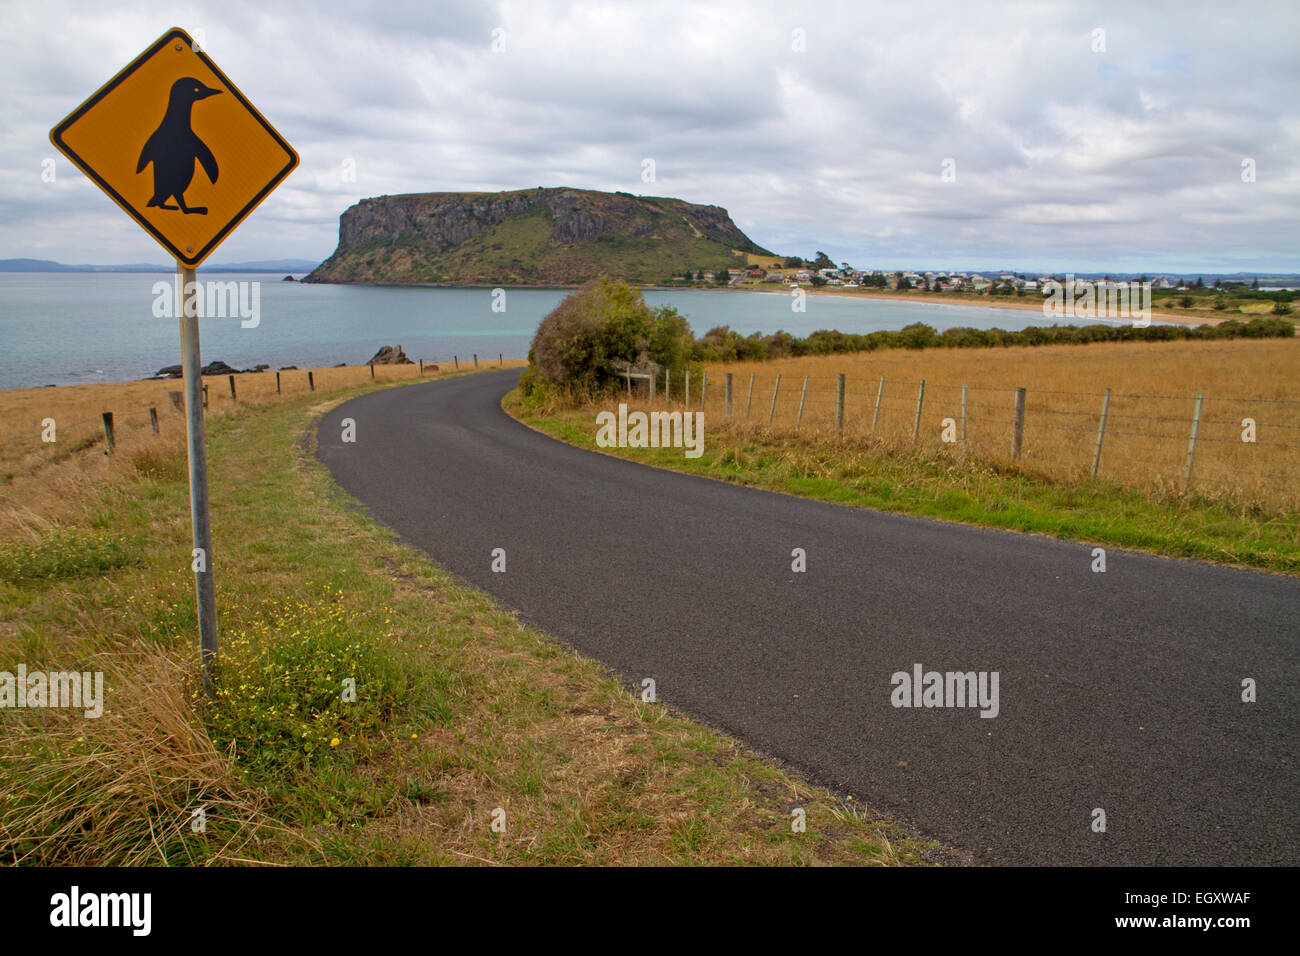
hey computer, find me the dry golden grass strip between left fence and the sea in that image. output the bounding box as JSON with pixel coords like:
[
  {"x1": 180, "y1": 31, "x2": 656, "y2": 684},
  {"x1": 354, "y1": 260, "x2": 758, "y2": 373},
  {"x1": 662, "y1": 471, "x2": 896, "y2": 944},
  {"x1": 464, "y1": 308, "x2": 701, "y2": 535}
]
[{"x1": 0, "y1": 359, "x2": 525, "y2": 540}]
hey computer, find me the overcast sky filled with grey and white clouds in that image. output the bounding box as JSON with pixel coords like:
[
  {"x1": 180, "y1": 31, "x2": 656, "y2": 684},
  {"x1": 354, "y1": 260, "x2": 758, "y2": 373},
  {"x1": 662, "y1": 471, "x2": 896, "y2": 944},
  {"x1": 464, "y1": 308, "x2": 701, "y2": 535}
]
[{"x1": 0, "y1": 0, "x2": 1300, "y2": 272}]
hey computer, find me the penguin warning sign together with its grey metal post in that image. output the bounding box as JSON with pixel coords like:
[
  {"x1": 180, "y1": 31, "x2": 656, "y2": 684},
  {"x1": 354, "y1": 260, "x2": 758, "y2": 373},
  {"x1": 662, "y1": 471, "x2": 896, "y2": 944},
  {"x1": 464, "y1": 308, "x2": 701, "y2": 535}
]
[{"x1": 49, "y1": 29, "x2": 298, "y2": 695}]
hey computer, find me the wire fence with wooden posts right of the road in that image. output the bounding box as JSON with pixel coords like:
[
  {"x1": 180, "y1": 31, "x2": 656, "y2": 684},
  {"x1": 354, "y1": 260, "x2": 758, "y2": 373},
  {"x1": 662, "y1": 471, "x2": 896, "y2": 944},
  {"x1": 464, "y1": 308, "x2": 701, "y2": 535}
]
[{"x1": 629, "y1": 372, "x2": 1300, "y2": 510}]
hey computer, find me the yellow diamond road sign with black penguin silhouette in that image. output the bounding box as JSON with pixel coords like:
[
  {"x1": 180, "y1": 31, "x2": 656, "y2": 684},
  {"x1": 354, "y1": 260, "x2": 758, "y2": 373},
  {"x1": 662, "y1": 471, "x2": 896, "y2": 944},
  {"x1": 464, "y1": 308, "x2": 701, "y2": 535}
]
[{"x1": 49, "y1": 29, "x2": 298, "y2": 267}]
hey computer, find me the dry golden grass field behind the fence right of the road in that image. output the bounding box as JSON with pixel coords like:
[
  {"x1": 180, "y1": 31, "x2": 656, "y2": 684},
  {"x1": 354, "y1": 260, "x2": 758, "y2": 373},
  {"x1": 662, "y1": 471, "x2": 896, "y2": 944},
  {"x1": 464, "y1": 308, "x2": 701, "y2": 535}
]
[{"x1": 686, "y1": 339, "x2": 1300, "y2": 511}]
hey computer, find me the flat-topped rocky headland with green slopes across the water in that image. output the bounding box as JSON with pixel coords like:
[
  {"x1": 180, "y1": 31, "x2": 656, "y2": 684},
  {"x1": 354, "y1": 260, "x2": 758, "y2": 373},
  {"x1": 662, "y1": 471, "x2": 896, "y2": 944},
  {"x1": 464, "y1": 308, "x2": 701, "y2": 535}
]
[{"x1": 304, "y1": 187, "x2": 771, "y2": 285}]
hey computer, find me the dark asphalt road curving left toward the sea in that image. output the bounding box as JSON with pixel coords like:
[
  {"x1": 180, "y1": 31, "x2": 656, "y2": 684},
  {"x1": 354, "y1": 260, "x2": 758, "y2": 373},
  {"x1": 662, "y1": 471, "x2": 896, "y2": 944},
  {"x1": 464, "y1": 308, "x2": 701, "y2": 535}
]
[{"x1": 317, "y1": 371, "x2": 1300, "y2": 865}]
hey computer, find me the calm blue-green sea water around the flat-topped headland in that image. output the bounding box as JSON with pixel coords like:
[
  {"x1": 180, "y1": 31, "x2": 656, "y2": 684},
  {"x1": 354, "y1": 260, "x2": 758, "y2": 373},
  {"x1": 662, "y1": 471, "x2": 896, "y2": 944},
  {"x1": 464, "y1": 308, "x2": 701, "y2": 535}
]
[{"x1": 0, "y1": 269, "x2": 1066, "y2": 388}]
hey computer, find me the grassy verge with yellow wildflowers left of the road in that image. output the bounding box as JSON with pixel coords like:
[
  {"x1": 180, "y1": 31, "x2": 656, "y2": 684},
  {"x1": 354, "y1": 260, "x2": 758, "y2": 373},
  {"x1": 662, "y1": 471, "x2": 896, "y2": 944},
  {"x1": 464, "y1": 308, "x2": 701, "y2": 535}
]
[{"x1": 0, "y1": 377, "x2": 924, "y2": 864}]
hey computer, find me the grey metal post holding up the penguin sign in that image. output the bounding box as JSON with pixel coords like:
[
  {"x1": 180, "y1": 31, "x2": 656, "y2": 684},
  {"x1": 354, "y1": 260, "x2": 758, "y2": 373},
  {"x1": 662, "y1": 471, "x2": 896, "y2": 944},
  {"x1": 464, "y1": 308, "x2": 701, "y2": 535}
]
[{"x1": 176, "y1": 263, "x2": 217, "y2": 697}]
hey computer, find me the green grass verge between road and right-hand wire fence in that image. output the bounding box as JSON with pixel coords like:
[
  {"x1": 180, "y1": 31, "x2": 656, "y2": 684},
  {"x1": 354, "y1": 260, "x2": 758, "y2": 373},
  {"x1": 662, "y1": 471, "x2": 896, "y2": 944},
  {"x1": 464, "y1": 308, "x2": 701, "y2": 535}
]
[{"x1": 504, "y1": 392, "x2": 1300, "y2": 575}]
